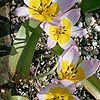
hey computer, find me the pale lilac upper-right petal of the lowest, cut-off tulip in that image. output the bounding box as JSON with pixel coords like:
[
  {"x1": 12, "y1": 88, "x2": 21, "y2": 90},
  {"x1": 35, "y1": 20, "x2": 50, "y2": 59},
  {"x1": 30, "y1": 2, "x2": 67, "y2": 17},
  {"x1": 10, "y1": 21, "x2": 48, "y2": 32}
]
[{"x1": 59, "y1": 80, "x2": 76, "y2": 93}]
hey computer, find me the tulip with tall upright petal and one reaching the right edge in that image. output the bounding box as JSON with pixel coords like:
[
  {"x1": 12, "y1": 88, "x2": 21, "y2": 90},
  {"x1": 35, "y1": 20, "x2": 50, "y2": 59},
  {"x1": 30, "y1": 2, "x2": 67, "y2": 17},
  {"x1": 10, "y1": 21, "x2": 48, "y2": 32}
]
[{"x1": 57, "y1": 46, "x2": 100, "y2": 82}]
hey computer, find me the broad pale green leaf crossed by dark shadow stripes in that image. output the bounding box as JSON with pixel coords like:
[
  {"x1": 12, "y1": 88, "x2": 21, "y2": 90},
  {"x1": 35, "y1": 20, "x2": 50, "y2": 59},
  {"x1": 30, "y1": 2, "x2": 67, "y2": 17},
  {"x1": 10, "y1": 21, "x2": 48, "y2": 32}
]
[{"x1": 9, "y1": 20, "x2": 32, "y2": 71}]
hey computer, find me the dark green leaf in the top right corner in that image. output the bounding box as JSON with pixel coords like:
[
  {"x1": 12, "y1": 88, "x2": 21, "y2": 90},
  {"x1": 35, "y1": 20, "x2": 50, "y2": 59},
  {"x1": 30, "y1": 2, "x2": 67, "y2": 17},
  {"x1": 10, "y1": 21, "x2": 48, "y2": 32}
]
[{"x1": 81, "y1": 0, "x2": 100, "y2": 13}]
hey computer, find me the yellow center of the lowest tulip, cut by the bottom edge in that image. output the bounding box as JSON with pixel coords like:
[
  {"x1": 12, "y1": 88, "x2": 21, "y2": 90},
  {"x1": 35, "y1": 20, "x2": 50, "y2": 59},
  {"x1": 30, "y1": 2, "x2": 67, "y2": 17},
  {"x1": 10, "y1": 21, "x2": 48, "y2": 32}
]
[{"x1": 45, "y1": 87, "x2": 74, "y2": 100}]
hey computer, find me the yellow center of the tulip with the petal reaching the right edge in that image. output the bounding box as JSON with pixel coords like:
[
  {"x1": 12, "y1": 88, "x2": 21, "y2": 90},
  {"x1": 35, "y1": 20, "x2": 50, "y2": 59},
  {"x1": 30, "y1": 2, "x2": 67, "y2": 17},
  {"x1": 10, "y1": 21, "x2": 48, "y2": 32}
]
[{"x1": 58, "y1": 60, "x2": 86, "y2": 82}]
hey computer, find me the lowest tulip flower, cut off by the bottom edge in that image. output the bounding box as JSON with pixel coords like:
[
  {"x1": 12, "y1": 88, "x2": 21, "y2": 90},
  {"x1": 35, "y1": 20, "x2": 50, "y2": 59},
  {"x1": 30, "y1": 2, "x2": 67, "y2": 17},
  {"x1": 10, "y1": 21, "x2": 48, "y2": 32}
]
[{"x1": 37, "y1": 80, "x2": 79, "y2": 100}]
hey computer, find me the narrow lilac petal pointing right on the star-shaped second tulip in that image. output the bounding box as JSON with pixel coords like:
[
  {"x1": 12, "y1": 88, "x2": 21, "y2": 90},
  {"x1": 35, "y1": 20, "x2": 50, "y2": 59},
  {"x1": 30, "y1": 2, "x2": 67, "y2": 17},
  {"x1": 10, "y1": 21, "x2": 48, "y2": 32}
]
[{"x1": 71, "y1": 26, "x2": 88, "y2": 37}]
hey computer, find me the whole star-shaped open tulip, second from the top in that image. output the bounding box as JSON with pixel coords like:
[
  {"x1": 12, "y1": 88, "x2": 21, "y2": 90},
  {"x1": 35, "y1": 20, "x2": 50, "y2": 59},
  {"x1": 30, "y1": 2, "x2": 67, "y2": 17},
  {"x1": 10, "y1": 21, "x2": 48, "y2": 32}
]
[{"x1": 41, "y1": 9, "x2": 87, "y2": 49}]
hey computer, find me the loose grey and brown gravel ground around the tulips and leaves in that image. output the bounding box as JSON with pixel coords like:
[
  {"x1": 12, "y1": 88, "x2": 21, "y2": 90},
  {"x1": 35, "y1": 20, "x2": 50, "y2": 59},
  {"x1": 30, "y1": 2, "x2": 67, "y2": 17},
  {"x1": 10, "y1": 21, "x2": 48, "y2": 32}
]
[{"x1": 0, "y1": 0, "x2": 100, "y2": 100}]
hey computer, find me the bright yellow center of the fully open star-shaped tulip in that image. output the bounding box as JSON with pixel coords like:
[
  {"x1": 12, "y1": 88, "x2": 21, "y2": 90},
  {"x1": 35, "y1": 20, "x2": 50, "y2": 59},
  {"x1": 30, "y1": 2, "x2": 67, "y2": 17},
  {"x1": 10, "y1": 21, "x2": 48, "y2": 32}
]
[{"x1": 49, "y1": 18, "x2": 72, "y2": 44}]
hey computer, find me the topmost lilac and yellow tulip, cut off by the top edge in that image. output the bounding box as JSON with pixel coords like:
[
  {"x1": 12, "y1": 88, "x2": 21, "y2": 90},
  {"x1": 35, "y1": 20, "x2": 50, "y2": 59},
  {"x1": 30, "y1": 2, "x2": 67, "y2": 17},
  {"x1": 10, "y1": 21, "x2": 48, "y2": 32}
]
[{"x1": 15, "y1": 0, "x2": 75, "y2": 24}]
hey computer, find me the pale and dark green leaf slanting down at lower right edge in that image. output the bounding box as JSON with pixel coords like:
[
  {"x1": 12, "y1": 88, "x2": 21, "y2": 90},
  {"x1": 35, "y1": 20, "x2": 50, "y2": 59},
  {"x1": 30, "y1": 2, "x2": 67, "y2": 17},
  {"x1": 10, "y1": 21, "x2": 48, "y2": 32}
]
[{"x1": 82, "y1": 74, "x2": 100, "y2": 100}]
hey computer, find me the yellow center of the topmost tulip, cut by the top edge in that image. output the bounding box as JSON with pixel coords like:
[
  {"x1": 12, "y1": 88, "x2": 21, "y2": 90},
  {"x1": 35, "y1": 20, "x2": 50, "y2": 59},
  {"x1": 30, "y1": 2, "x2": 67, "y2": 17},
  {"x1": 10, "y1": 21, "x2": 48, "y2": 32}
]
[{"x1": 28, "y1": 0, "x2": 59, "y2": 21}]
